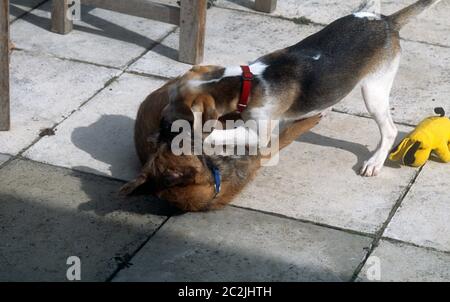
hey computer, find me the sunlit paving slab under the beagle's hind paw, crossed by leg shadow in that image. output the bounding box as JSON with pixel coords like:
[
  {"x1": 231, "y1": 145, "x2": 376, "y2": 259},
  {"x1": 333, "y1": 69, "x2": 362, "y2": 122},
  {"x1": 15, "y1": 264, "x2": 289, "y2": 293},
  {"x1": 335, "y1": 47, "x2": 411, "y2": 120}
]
[{"x1": 234, "y1": 113, "x2": 417, "y2": 233}]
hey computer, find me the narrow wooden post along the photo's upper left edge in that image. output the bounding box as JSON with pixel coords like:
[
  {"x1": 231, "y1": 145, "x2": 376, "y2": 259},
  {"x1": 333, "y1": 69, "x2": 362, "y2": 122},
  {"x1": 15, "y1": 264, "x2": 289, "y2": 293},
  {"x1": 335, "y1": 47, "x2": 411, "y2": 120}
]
[{"x1": 0, "y1": 0, "x2": 10, "y2": 131}]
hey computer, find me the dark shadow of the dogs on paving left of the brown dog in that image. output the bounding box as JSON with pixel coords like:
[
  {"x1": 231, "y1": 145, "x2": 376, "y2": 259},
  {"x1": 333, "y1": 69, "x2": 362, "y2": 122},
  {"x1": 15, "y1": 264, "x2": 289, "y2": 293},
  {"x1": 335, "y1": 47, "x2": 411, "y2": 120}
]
[{"x1": 71, "y1": 114, "x2": 180, "y2": 216}]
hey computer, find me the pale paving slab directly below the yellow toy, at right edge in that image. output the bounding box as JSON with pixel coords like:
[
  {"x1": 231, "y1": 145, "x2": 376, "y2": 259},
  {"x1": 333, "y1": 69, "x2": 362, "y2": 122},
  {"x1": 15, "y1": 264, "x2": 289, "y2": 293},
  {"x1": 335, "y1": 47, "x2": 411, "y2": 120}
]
[{"x1": 384, "y1": 161, "x2": 450, "y2": 252}]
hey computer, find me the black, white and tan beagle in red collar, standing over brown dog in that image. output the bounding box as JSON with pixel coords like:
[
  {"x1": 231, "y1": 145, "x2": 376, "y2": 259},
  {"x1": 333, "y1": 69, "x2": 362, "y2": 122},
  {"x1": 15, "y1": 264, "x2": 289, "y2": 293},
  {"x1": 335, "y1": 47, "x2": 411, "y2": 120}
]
[{"x1": 161, "y1": 0, "x2": 440, "y2": 176}]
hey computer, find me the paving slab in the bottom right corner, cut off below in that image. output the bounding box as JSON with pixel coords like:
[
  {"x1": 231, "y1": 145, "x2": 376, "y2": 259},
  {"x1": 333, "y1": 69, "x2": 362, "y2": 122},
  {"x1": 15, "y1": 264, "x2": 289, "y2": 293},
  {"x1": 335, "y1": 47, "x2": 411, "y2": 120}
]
[{"x1": 357, "y1": 240, "x2": 450, "y2": 282}]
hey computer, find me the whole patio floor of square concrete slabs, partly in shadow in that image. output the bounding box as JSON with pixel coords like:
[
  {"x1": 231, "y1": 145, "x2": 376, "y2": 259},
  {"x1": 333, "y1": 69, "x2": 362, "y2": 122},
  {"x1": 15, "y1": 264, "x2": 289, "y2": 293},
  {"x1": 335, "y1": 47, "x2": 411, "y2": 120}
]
[{"x1": 0, "y1": 0, "x2": 450, "y2": 281}]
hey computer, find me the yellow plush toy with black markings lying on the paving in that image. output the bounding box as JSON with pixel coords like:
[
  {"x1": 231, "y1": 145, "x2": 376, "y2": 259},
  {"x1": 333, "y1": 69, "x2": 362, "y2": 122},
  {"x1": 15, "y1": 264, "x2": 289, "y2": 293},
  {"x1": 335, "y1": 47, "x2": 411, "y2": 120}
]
[{"x1": 389, "y1": 108, "x2": 450, "y2": 167}]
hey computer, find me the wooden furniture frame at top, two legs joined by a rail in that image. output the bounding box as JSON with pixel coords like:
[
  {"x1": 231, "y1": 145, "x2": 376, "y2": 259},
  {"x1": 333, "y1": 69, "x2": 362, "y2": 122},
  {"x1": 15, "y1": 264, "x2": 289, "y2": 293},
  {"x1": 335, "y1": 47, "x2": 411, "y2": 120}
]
[{"x1": 51, "y1": 0, "x2": 207, "y2": 64}]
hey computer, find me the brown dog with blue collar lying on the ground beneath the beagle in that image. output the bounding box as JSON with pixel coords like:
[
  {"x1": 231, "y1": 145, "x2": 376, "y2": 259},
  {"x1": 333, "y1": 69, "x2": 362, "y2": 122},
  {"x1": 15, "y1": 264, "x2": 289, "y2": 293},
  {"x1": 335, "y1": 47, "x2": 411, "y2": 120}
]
[{"x1": 120, "y1": 78, "x2": 321, "y2": 211}]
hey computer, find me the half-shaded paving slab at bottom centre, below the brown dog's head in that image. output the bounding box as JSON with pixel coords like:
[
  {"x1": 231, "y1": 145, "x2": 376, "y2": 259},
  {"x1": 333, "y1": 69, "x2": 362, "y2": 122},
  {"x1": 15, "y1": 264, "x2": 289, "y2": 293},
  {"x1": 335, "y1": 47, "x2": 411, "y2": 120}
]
[{"x1": 113, "y1": 207, "x2": 371, "y2": 282}]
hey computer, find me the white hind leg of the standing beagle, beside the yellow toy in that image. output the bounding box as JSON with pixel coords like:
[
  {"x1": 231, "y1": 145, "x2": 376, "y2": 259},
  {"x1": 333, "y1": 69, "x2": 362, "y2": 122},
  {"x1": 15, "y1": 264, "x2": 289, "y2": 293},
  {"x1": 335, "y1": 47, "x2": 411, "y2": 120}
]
[{"x1": 361, "y1": 56, "x2": 400, "y2": 177}]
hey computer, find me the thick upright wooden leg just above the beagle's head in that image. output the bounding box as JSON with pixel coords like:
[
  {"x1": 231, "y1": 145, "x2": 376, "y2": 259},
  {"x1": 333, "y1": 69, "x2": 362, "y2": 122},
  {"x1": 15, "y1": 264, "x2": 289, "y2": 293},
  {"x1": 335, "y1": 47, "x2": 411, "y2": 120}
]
[{"x1": 178, "y1": 0, "x2": 207, "y2": 64}]
